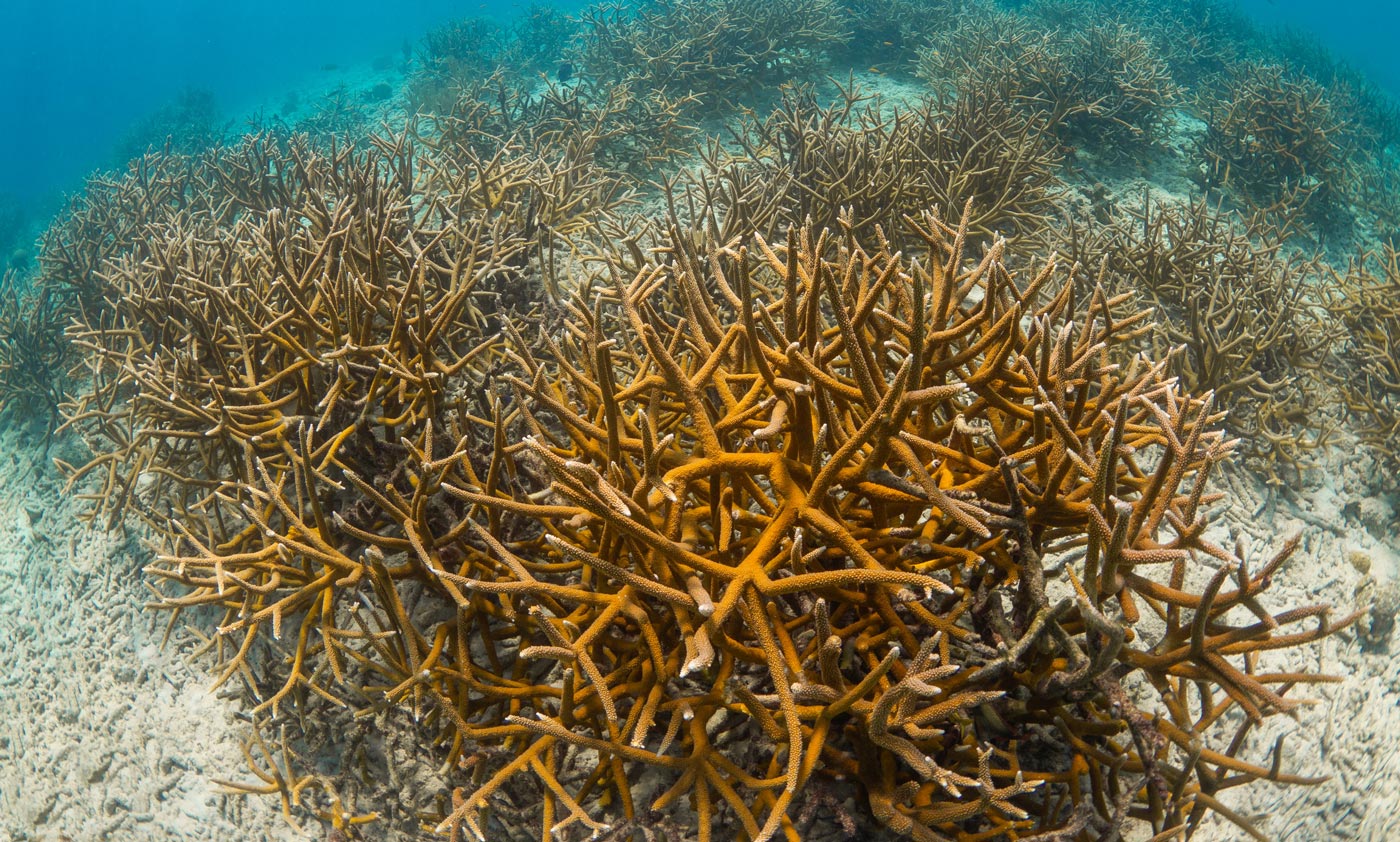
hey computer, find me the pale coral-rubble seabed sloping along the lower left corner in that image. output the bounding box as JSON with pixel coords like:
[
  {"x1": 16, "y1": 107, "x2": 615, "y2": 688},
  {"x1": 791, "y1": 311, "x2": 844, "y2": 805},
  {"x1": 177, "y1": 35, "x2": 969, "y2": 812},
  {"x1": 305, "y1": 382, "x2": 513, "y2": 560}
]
[{"x1": 0, "y1": 430, "x2": 309, "y2": 842}]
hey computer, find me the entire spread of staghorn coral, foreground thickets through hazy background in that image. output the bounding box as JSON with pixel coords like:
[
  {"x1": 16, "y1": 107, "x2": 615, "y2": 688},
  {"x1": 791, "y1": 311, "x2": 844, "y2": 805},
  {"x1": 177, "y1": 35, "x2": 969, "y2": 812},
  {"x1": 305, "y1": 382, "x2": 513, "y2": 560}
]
[{"x1": 0, "y1": 0, "x2": 1400, "y2": 842}]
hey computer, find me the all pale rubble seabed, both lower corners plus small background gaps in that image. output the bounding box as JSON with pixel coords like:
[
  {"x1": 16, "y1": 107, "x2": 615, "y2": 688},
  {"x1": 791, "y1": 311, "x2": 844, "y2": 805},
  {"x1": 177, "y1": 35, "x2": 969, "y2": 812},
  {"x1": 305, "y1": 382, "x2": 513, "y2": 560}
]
[{"x1": 0, "y1": 67, "x2": 1400, "y2": 842}]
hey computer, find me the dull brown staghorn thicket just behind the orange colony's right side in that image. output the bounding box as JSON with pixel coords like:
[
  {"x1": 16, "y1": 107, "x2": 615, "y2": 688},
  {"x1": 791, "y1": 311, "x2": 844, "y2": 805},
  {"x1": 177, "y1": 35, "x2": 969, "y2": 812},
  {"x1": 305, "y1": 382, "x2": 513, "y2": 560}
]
[{"x1": 1061, "y1": 195, "x2": 1340, "y2": 482}]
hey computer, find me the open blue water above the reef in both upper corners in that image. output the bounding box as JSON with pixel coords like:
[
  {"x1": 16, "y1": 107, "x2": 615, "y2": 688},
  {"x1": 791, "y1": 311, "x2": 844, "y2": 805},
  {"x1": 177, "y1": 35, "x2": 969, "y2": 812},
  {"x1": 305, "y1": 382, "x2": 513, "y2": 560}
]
[{"x1": 0, "y1": 0, "x2": 1400, "y2": 216}]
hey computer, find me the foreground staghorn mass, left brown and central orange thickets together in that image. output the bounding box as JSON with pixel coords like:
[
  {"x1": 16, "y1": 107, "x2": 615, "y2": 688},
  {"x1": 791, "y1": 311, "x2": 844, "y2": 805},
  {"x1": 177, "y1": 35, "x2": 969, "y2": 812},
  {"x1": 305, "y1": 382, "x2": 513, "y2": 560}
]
[{"x1": 51, "y1": 154, "x2": 1350, "y2": 839}]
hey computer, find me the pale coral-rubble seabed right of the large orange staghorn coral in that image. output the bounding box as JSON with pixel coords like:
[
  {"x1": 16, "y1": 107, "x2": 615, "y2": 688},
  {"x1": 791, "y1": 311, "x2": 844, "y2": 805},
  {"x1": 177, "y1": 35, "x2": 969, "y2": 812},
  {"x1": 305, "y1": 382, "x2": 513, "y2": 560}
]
[{"x1": 1203, "y1": 443, "x2": 1400, "y2": 842}]
